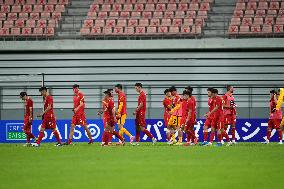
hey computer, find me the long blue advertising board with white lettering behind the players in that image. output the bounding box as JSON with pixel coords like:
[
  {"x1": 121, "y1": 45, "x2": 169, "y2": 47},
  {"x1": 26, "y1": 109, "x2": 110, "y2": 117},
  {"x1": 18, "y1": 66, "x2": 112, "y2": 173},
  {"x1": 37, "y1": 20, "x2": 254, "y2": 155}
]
[{"x1": 0, "y1": 119, "x2": 278, "y2": 143}]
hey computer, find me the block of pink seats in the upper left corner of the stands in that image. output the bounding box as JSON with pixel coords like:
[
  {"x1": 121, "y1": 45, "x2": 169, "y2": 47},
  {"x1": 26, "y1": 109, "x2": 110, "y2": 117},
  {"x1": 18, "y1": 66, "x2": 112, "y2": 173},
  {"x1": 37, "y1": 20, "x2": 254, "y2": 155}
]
[{"x1": 0, "y1": 0, "x2": 69, "y2": 38}]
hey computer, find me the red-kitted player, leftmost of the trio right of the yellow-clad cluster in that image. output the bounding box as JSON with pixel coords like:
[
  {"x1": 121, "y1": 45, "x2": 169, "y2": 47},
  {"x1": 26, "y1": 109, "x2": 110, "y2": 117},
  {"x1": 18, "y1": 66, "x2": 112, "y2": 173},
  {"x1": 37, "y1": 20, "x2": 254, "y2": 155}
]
[{"x1": 202, "y1": 87, "x2": 215, "y2": 145}]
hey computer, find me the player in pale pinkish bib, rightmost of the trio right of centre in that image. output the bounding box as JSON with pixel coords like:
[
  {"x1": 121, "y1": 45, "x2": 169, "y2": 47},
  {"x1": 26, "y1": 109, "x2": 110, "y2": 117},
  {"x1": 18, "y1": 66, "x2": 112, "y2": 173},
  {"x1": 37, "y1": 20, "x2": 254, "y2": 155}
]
[{"x1": 223, "y1": 85, "x2": 237, "y2": 144}]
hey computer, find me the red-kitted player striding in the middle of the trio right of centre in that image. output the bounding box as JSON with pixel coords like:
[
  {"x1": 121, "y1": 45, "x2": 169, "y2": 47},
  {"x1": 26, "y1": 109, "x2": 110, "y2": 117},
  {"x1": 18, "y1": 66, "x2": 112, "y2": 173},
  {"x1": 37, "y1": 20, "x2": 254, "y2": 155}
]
[{"x1": 206, "y1": 89, "x2": 232, "y2": 146}]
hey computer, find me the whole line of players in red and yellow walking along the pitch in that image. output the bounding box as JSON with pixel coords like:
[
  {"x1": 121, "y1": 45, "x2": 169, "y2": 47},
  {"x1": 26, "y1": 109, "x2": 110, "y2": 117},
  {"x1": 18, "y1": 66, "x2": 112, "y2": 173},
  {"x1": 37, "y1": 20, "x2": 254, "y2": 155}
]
[{"x1": 20, "y1": 83, "x2": 284, "y2": 147}]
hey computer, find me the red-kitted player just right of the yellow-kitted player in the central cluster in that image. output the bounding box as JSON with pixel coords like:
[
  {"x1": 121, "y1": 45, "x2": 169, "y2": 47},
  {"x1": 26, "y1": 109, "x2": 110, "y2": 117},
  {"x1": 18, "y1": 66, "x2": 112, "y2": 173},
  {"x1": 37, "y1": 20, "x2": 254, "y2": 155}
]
[{"x1": 181, "y1": 90, "x2": 198, "y2": 146}]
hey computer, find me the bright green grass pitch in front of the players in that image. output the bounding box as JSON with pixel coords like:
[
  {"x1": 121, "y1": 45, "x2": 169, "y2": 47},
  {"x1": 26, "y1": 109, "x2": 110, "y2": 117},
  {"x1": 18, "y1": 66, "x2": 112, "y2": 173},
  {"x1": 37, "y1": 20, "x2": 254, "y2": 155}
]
[{"x1": 0, "y1": 143, "x2": 284, "y2": 189}]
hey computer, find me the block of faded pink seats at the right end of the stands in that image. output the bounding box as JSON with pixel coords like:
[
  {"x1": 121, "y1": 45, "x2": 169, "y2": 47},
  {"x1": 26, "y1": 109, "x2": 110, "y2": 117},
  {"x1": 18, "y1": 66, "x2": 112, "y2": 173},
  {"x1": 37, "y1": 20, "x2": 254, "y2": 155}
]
[{"x1": 228, "y1": 0, "x2": 284, "y2": 37}]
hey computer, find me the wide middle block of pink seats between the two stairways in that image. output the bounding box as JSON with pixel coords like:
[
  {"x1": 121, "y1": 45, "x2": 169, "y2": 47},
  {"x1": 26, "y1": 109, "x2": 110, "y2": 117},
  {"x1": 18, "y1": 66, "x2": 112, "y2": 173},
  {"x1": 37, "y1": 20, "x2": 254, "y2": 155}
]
[{"x1": 80, "y1": 0, "x2": 213, "y2": 37}]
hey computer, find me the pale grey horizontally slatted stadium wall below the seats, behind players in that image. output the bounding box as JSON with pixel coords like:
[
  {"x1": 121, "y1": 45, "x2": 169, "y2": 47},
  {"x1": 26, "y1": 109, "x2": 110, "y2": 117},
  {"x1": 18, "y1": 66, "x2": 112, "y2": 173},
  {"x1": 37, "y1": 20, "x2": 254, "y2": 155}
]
[{"x1": 0, "y1": 39, "x2": 284, "y2": 120}]
